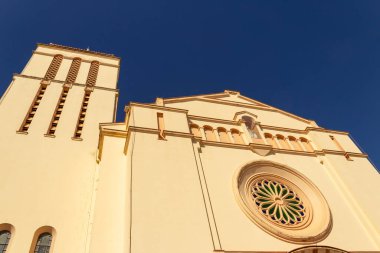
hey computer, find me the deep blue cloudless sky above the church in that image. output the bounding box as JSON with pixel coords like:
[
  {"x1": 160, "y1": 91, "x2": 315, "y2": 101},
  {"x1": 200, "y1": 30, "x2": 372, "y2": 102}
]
[{"x1": 0, "y1": 0, "x2": 380, "y2": 166}]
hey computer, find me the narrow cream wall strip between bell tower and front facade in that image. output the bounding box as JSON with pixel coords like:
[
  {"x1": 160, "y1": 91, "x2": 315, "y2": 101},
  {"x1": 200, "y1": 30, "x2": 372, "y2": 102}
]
[{"x1": 89, "y1": 136, "x2": 130, "y2": 253}]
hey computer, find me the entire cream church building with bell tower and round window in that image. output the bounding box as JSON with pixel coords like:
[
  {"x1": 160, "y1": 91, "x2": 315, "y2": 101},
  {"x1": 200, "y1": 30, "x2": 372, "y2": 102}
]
[{"x1": 0, "y1": 44, "x2": 380, "y2": 253}]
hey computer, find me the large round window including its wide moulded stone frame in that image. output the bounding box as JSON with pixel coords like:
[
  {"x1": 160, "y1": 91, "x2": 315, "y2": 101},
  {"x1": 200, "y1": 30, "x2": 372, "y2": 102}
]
[{"x1": 234, "y1": 161, "x2": 331, "y2": 244}]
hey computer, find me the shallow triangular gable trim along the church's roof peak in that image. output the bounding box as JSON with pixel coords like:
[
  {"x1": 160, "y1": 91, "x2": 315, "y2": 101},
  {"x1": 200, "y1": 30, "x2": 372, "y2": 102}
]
[{"x1": 163, "y1": 90, "x2": 315, "y2": 124}]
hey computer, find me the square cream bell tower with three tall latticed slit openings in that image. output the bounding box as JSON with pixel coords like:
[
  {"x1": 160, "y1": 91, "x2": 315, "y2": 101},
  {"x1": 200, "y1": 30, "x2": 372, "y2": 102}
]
[{"x1": 0, "y1": 44, "x2": 120, "y2": 252}]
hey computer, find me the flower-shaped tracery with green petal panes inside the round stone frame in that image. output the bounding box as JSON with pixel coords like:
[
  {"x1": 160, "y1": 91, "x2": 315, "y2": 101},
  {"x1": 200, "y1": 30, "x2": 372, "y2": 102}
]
[{"x1": 251, "y1": 179, "x2": 306, "y2": 226}]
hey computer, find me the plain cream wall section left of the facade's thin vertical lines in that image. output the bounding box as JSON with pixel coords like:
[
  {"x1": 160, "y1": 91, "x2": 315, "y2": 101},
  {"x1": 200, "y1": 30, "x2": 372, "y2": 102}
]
[{"x1": 122, "y1": 133, "x2": 213, "y2": 253}]
